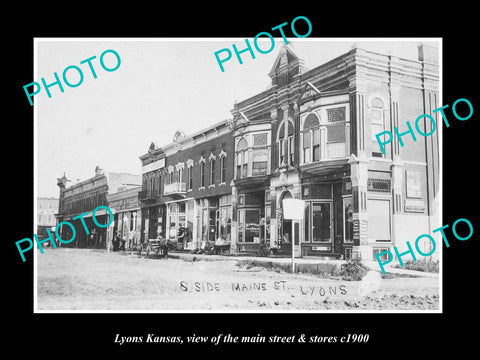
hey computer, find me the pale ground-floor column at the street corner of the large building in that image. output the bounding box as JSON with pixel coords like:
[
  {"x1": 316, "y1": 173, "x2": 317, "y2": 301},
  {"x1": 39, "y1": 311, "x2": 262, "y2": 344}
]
[{"x1": 349, "y1": 155, "x2": 372, "y2": 260}]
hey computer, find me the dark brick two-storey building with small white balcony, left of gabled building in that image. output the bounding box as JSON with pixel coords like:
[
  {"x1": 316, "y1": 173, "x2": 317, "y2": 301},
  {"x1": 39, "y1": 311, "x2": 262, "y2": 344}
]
[{"x1": 139, "y1": 121, "x2": 233, "y2": 250}]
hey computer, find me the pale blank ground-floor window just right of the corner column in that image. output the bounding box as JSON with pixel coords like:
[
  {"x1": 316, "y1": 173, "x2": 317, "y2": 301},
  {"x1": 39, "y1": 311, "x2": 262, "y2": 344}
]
[{"x1": 367, "y1": 199, "x2": 391, "y2": 242}]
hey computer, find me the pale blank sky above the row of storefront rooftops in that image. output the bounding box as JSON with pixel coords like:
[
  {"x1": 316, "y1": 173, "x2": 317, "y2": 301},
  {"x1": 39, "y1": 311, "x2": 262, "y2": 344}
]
[{"x1": 35, "y1": 38, "x2": 440, "y2": 197}]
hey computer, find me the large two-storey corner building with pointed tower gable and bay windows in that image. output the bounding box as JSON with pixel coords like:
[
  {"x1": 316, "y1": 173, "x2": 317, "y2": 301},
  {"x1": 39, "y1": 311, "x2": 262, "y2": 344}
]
[{"x1": 229, "y1": 45, "x2": 440, "y2": 260}]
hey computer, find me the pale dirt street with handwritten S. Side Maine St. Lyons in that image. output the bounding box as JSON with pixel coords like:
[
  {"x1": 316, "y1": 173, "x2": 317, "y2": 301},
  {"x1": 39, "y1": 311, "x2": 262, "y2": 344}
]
[{"x1": 37, "y1": 249, "x2": 439, "y2": 312}]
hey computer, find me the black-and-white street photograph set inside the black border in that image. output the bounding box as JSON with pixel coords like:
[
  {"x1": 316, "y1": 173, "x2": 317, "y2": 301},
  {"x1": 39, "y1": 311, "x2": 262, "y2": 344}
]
[{"x1": 32, "y1": 37, "x2": 440, "y2": 312}]
